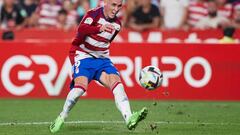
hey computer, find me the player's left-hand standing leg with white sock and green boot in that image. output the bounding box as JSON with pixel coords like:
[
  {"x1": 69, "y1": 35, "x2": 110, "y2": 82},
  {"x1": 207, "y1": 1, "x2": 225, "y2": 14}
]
[{"x1": 50, "y1": 76, "x2": 88, "y2": 133}]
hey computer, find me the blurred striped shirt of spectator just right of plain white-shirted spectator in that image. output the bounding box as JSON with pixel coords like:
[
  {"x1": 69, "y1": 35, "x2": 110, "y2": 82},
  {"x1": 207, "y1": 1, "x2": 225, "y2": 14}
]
[{"x1": 187, "y1": 1, "x2": 208, "y2": 27}]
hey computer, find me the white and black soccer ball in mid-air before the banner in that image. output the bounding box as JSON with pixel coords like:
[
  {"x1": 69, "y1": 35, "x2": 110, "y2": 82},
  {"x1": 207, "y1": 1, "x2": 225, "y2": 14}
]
[{"x1": 139, "y1": 66, "x2": 163, "y2": 90}]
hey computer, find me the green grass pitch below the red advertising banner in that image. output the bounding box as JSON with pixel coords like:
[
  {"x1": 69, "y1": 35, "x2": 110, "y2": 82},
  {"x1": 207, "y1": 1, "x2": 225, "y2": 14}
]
[{"x1": 0, "y1": 99, "x2": 240, "y2": 135}]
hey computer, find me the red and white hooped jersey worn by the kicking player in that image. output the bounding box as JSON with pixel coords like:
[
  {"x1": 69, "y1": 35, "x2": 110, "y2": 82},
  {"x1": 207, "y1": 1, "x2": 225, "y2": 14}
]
[{"x1": 70, "y1": 7, "x2": 121, "y2": 62}]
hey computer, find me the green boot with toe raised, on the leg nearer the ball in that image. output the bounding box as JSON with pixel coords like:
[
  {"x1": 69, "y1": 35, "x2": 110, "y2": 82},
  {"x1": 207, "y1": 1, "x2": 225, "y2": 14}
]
[{"x1": 127, "y1": 107, "x2": 148, "y2": 130}]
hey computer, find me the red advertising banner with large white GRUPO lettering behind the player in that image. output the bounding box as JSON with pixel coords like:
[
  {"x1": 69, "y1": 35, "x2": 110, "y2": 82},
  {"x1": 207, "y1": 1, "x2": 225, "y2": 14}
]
[{"x1": 0, "y1": 42, "x2": 240, "y2": 100}]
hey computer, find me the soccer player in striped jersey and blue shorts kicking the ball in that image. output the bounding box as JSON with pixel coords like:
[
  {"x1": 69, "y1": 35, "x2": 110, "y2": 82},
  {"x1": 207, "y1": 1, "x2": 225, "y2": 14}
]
[{"x1": 50, "y1": 0, "x2": 148, "y2": 133}]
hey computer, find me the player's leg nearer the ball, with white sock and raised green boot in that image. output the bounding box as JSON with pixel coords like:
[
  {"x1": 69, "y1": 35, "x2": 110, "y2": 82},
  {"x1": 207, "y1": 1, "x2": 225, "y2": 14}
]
[{"x1": 100, "y1": 72, "x2": 147, "y2": 130}]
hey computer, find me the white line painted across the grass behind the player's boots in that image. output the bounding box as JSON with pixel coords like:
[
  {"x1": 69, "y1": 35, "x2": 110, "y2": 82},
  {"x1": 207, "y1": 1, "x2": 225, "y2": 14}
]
[{"x1": 0, "y1": 121, "x2": 240, "y2": 126}]
